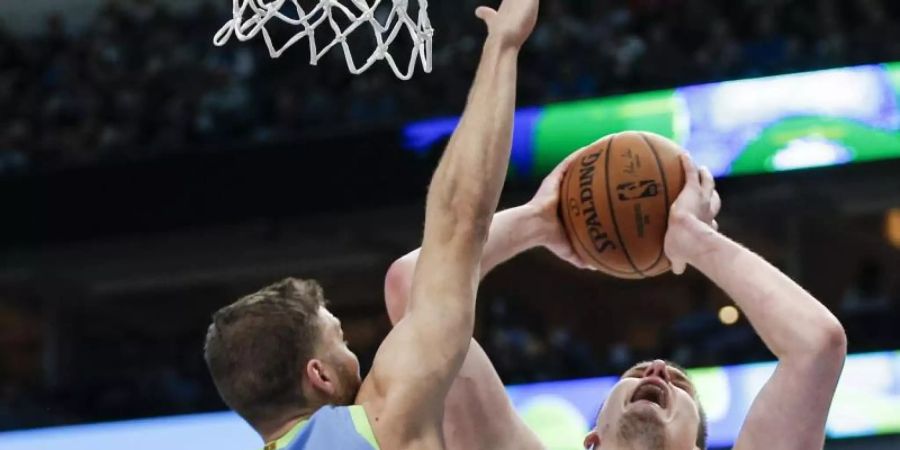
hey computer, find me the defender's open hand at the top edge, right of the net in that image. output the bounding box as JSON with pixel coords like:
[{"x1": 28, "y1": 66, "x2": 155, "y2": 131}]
[{"x1": 475, "y1": 0, "x2": 540, "y2": 48}]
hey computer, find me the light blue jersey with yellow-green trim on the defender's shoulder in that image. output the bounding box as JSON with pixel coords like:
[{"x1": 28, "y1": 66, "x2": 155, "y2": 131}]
[{"x1": 263, "y1": 405, "x2": 379, "y2": 450}]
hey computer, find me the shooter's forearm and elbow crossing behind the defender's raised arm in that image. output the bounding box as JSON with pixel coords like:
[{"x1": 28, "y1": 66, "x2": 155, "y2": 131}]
[{"x1": 384, "y1": 205, "x2": 543, "y2": 324}]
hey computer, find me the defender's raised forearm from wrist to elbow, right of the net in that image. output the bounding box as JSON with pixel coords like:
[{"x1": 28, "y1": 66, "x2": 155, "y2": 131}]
[{"x1": 425, "y1": 37, "x2": 518, "y2": 245}]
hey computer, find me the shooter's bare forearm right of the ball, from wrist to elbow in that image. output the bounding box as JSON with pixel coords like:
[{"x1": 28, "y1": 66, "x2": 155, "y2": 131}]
[{"x1": 688, "y1": 216, "x2": 846, "y2": 360}]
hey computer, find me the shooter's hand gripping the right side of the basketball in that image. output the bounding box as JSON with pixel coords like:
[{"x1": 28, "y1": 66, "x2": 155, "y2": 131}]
[{"x1": 665, "y1": 153, "x2": 722, "y2": 275}]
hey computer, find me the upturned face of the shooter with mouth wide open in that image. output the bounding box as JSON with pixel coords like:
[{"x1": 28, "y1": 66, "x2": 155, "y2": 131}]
[{"x1": 585, "y1": 361, "x2": 700, "y2": 450}]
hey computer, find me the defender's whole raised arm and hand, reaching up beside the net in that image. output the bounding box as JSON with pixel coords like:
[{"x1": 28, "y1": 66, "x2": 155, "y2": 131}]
[{"x1": 358, "y1": 0, "x2": 538, "y2": 448}]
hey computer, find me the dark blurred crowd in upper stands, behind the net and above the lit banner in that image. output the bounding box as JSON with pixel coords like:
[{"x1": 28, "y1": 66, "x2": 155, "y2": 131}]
[{"x1": 0, "y1": 0, "x2": 900, "y2": 174}]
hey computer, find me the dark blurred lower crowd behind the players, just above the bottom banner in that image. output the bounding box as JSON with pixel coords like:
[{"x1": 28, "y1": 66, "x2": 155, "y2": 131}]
[{"x1": 0, "y1": 260, "x2": 900, "y2": 431}]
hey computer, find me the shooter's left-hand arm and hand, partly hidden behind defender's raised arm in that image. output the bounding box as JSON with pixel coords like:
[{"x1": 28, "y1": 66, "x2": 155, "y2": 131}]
[{"x1": 384, "y1": 158, "x2": 584, "y2": 450}]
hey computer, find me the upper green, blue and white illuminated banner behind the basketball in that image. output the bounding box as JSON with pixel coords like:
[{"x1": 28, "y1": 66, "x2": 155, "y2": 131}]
[{"x1": 404, "y1": 63, "x2": 900, "y2": 177}]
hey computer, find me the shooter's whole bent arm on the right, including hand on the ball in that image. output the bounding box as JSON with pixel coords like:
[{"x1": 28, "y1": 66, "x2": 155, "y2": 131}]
[{"x1": 666, "y1": 158, "x2": 847, "y2": 450}]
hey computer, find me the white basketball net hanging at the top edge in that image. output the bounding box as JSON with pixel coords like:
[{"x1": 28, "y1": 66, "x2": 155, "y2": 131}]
[{"x1": 213, "y1": 0, "x2": 434, "y2": 80}]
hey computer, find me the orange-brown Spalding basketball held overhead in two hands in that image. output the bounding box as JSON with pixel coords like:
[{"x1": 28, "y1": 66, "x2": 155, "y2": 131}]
[{"x1": 560, "y1": 131, "x2": 684, "y2": 279}]
